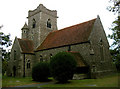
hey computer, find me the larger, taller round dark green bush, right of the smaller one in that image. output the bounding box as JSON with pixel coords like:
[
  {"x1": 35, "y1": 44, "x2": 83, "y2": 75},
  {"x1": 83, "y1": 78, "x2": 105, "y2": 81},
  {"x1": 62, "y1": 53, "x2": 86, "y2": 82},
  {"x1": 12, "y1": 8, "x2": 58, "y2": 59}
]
[{"x1": 50, "y1": 52, "x2": 76, "y2": 83}]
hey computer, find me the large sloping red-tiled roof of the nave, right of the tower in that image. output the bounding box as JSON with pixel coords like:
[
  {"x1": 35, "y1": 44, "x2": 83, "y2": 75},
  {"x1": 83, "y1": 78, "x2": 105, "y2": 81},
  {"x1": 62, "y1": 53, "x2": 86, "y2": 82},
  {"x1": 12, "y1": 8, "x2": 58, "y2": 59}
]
[{"x1": 36, "y1": 19, "x2": 96, "y2": 51}]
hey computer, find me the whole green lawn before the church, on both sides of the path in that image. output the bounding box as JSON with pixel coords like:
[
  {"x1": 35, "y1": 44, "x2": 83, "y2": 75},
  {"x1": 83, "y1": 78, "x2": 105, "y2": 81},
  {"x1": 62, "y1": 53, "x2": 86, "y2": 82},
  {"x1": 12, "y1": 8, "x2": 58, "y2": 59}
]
[{"x1": 2, "y1": 73, "x2": 120, "y2": 87}]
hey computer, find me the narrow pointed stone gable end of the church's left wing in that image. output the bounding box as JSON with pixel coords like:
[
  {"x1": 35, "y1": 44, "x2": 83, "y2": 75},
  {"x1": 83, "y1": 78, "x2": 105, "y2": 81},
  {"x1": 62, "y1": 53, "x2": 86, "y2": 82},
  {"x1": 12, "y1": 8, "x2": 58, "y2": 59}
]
[{"x1": 7, "y1": 38, "x2": 22, "y2": 76}]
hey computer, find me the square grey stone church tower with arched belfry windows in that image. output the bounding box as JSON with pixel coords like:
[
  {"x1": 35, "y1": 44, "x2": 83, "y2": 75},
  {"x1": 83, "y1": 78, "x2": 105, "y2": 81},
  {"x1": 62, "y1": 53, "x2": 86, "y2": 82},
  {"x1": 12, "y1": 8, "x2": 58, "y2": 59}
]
[{"x1": 26, "y1": 4, "x2": 57, "y2": 49}]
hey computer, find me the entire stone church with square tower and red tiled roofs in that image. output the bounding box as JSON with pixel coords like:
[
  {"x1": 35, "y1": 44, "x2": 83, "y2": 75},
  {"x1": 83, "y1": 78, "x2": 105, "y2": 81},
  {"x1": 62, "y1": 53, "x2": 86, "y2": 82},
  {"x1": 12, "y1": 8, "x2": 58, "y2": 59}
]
[{"x1": 7, "y1": 4, "x2": 114, "y2": 78}]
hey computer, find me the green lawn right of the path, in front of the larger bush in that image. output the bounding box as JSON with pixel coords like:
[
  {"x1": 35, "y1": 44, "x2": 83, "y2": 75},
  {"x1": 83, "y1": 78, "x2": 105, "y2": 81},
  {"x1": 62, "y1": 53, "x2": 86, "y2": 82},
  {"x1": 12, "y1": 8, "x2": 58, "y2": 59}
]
[{"x1": 41, "y1": 73, "x2": 120, "y2": 87}]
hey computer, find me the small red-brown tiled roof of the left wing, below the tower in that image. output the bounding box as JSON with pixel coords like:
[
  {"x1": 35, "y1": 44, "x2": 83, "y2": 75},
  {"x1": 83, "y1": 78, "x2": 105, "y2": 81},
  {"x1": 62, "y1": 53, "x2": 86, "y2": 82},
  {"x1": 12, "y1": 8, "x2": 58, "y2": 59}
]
[{"x1": 18, "y1": 38, "x2": 34, "y2": 53}]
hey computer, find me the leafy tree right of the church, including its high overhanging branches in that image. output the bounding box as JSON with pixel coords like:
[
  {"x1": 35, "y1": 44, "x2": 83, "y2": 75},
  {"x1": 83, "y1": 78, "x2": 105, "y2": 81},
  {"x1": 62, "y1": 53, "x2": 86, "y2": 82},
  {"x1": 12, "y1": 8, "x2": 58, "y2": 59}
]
[{"x1": 108, "y1": 0, "x2": 120, "y2": 71}]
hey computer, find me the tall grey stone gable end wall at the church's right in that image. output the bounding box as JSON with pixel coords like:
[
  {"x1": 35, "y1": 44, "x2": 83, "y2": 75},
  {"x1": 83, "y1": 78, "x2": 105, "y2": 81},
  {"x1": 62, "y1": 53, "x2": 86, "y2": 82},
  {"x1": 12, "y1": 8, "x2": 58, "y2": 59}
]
[{"x1": 89, "y1": 17, "x2": 116, "y2": 76}]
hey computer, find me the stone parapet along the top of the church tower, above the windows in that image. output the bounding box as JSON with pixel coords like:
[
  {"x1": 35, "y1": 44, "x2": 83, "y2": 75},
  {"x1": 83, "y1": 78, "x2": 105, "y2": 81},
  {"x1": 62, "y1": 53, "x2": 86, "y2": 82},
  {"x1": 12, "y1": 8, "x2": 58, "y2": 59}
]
[{"x1": 28, "y1": 4, "x2": 58, "y2": 18}]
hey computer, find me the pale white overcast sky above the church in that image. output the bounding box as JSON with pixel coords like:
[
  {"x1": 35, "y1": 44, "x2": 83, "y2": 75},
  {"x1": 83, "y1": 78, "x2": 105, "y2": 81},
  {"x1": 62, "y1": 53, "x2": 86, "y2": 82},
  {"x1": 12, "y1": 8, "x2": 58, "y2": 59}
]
[{"x1": 0, "y1": 0, "x2": 116, "y2": 46}]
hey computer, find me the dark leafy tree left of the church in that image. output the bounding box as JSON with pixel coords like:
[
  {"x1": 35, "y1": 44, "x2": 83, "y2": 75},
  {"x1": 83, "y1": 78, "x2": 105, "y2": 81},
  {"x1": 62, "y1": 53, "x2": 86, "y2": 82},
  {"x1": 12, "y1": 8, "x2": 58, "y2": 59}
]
[{"x1": 0, "y1": 26, "x2": 12, "y2": 75}]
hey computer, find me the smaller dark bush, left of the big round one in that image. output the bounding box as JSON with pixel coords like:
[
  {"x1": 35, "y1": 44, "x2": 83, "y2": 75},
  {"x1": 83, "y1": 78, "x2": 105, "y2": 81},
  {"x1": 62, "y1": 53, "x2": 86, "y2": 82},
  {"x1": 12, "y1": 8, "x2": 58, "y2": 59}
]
[{"x1": 32, "y1": 62, "x2": 50, "y2": 81}]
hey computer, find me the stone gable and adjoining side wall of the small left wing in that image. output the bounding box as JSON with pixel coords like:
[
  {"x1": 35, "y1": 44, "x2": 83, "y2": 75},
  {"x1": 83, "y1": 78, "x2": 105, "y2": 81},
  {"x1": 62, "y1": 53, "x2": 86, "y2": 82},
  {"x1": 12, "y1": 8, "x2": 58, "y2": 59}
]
[{"x1": 7, "y1": 38, "x2": 34, "y2": 77}]
